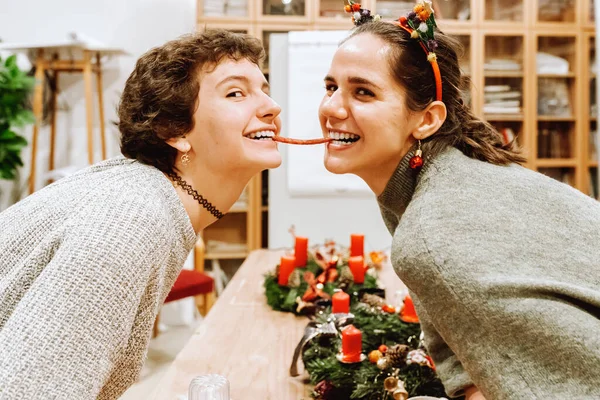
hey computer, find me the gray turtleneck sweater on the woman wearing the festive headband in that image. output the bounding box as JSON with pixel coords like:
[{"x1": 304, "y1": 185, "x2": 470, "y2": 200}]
[{"x1": 378, "y1": 148, "x2": 600, "y2": 400}]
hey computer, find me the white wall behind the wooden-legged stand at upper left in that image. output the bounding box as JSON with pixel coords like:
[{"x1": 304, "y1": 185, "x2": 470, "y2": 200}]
[{"x1": 0, "y1": 0, "x2": 196, "y2": 210}]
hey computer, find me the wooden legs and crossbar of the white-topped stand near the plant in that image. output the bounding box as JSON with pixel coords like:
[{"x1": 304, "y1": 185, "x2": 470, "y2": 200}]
[{"x1": 29, "y1": 48, "x2": 106, "y2": 194}]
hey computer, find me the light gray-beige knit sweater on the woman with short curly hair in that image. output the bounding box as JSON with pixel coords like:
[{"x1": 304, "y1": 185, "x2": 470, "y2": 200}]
[{"x1": 0, "y1": 157, "x2": 196, "y2": 400}]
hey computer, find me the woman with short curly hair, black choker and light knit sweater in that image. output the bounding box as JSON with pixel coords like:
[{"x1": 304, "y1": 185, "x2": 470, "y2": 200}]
[{"x1": 0, "y1": 30, "x2": 281, "y2": 399}]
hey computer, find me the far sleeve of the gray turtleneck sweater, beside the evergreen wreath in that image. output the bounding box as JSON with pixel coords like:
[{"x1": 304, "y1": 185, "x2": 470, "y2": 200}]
[{"x1": 411, "y1": 293, "x2": 474, "y2": 398}]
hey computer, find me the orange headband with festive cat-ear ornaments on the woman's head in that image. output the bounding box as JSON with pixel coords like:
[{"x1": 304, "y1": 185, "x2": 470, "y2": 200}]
[{"x1": 344, "y1": 0, "x2": 442, "y2": 101}]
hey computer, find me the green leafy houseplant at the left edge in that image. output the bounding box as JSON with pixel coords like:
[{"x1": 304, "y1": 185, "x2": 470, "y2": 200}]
[{"x1": 0, "y1": 55, "x2": 35, "y2": 180}]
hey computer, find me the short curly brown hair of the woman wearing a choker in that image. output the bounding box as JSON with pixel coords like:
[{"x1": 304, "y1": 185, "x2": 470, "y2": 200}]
[{"x1": 116, "y1": 29, "x2": 265, "y2": 173}]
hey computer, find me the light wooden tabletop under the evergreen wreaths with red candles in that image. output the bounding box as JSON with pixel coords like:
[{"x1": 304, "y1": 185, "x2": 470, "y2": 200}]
[{"x1": 153, "y1": 250, "x2": 404, "y2": 400}]
